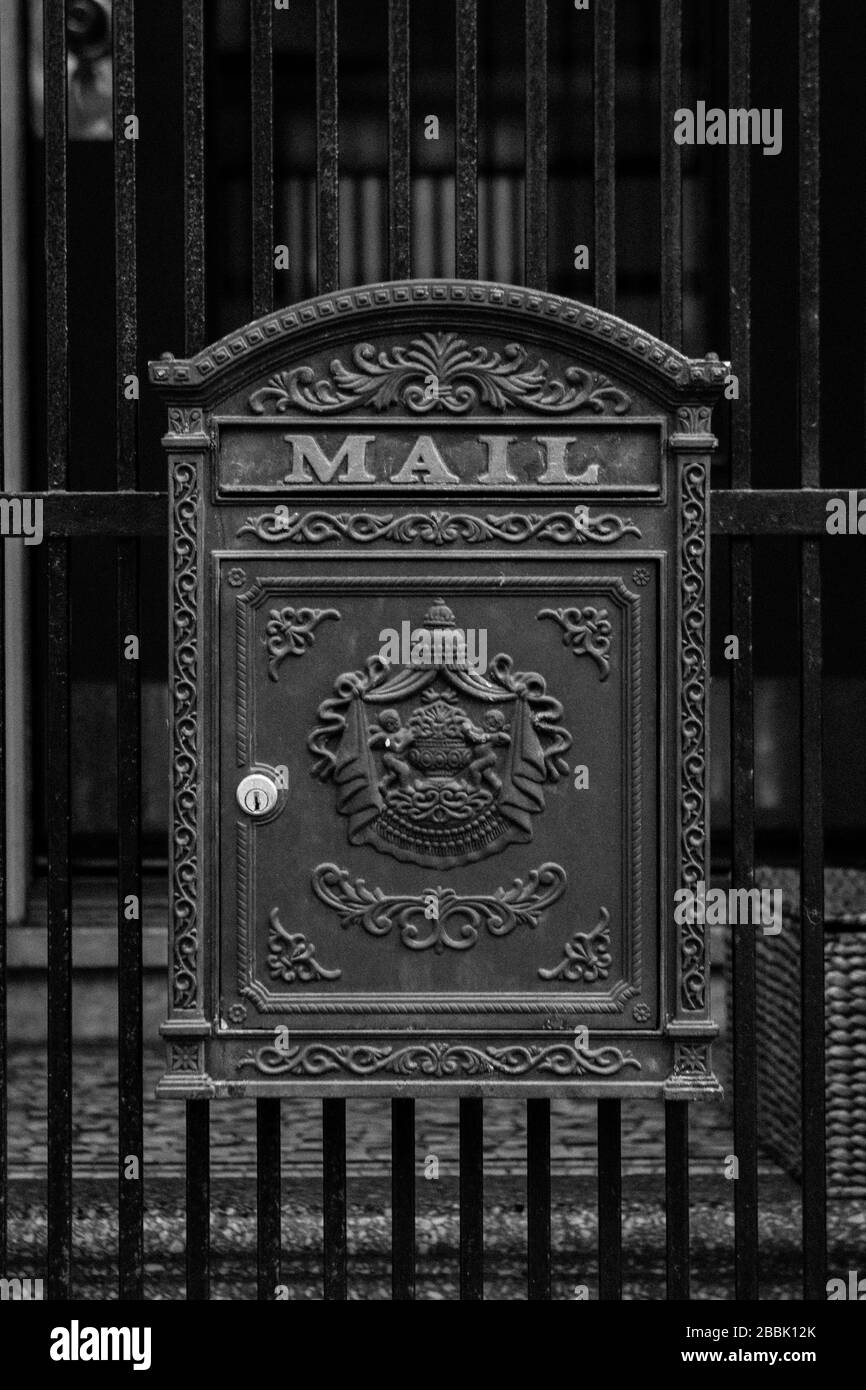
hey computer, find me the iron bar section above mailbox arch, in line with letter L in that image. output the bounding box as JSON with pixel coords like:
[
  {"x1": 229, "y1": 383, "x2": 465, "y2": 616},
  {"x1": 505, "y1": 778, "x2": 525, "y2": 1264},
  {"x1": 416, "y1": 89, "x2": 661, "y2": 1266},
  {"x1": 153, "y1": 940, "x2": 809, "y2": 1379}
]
[{"x1": 524, "y1": 0, "x2": 548, "y2": 289}]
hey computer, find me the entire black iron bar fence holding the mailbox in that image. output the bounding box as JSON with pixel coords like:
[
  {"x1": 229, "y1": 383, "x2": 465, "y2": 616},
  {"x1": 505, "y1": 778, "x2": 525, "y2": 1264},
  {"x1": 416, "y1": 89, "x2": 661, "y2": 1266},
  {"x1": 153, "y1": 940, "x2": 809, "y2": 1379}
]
[{"x1": 0, "y1": 0, "x2": 856, "y2": 1300}]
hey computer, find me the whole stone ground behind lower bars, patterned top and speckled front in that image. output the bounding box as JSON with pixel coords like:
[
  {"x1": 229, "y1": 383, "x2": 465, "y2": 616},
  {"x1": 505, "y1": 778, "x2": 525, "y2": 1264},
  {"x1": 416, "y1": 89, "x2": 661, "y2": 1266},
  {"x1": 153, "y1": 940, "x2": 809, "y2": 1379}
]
[{"x1": 10, "y1": 1023, "x2": 866, "y2": 1300}]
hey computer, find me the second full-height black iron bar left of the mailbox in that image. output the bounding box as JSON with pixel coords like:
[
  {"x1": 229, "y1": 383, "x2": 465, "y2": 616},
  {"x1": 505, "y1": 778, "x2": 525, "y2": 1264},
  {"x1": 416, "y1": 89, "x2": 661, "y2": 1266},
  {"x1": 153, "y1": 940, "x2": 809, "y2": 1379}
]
[{"x1": 43, "y1": 0, "x2": 72, "y2": 1300}]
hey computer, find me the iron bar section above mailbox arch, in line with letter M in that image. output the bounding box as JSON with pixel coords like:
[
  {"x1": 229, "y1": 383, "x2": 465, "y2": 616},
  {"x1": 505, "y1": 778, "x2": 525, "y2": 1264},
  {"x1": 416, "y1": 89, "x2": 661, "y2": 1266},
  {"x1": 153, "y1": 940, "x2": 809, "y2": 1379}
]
[{"x1": 316, "y1": 0, "x2": 339, "y2": 295}]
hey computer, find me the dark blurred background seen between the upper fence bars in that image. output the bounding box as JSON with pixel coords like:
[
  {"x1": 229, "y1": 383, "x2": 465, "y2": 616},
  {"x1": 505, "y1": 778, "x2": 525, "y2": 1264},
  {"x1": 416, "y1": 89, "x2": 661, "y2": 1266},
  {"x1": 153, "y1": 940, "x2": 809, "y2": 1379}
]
[{"x1": 4, "y1": 0, "x2": 866, "y2": 901}]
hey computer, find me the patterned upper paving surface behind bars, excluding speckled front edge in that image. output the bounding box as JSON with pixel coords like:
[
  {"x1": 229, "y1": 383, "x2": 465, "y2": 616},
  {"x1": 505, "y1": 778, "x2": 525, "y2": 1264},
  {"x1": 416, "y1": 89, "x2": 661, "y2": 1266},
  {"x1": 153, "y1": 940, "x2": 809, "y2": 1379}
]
[{"x1": 8, "y1": 1044, "x2": 731, "y2": 1182}]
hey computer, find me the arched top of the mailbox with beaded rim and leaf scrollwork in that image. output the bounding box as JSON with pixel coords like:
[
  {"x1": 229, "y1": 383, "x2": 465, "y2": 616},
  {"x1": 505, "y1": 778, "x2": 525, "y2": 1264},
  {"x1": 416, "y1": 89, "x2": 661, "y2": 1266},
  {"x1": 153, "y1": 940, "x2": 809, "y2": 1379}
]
[{"x1": 150, "y1": 279, "x2": 727, "y2": 419}]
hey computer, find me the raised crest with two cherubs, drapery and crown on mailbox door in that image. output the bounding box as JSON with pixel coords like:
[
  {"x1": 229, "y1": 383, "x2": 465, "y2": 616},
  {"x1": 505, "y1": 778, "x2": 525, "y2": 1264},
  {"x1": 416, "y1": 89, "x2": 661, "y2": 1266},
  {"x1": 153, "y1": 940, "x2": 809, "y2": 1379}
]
[{"x1": 307, "y1": 599, "x2": 571, "y2": 869}]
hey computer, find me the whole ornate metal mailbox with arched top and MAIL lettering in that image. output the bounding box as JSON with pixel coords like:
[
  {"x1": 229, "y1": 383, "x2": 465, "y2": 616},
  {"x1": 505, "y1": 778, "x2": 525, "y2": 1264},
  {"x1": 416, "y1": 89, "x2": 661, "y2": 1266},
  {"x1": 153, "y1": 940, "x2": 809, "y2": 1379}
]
[{"x1": 150, "y1": 281, "x2": 724, "y2": 1098}]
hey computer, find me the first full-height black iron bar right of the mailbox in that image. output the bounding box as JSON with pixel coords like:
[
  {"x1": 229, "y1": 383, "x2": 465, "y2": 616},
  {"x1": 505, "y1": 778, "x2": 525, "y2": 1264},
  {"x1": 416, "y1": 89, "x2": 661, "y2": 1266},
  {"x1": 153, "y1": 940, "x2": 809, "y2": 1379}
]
[{"x1": 728, "y1": 0, "x2": 759, "y2": 1301}]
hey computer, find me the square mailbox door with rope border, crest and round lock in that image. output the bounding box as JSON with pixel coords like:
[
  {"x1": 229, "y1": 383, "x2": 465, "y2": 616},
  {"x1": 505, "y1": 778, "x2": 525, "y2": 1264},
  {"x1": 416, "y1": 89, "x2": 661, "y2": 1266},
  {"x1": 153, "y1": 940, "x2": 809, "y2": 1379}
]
[{"x1": 218, "y1": 552, "x2": 664, "y2": 1030}]
